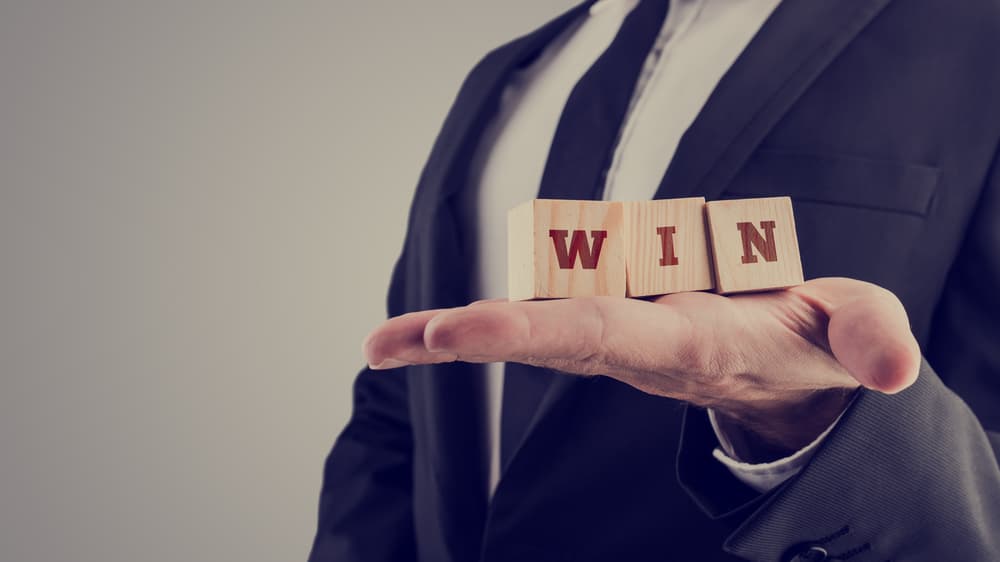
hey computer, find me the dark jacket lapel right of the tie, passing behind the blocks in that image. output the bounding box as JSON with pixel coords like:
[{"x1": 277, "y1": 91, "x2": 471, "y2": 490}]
[{"x1": 515, "y1": 0, "x2": 890, "y2": 472}]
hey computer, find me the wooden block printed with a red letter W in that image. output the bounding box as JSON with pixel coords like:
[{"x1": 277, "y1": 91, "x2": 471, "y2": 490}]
[{"x1": 507, "y1": 199, "x2": 625, "y2": 300}]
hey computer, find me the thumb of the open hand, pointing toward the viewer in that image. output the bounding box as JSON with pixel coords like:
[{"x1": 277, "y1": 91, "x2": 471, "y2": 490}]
[{"x1": 799, "y1": 278, "x2": 920, "y2": 393}]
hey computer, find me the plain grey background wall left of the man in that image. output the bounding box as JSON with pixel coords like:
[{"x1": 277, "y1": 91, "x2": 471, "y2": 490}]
[{"x1": 0, "y1": 0, "x2": 571, "y2": 562}]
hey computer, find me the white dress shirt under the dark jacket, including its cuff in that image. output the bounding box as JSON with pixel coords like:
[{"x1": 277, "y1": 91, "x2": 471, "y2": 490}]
[{"x1": 470, "y1": 0, "x2": 832, "y2": 495}]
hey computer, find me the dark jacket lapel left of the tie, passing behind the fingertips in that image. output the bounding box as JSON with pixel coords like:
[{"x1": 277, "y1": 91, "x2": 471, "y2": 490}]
[{"x1": 405, "y1": 0, "x2": 593, "y2": 560}]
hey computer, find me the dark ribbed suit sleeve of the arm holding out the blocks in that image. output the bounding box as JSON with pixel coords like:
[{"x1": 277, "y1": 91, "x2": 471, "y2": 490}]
[{"x1": 678, "y1": 148, "x2": 1000, "y2": 562}]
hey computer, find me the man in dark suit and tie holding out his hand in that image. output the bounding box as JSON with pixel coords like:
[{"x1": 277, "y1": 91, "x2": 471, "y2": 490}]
[{"x1": 311, "y1": 0, "x2": 1000, "y2": 562}]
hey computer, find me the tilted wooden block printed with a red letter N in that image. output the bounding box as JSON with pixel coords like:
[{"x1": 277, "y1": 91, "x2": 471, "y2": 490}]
[{"x1": 705, "y1": 197, "x2": 802, "y2": 294}]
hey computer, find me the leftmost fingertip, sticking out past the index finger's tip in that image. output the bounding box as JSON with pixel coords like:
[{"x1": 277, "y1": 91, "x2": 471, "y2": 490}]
[{"x1": 362, "y1": 310, "x2": 455, "y2": 369}]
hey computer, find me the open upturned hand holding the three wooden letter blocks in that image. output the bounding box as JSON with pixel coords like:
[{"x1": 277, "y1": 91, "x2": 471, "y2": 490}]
[{"x1": 364, "y1": 278, "x2": 920, "y2": 456}]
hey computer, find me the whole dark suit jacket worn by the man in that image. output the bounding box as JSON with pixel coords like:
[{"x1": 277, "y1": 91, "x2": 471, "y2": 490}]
[{"x1": 311, "y1": 0, "x2": 1000, "y2": 562}]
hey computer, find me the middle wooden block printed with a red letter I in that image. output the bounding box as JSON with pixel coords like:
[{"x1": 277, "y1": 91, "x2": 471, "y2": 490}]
[{"x1": 624, "y1": 197, "x2": 715, "y2": 297}]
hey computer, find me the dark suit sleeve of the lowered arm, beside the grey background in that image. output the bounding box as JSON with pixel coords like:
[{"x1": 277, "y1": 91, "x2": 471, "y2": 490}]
[{"x1": 309, "y1": 250, "x2": 416, "y2": 562}]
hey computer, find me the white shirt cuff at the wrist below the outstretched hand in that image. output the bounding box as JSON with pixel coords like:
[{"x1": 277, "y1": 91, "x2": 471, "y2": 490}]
[{"x1": 708, "y1": 404, "x2": 844, "y2": 493}]
